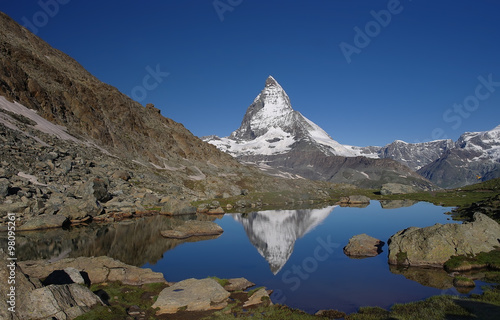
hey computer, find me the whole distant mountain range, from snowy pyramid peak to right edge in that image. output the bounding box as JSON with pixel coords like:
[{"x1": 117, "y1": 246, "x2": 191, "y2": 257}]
[{"x1": 202, "y1": 76, "x2": 500, "y2": 189}]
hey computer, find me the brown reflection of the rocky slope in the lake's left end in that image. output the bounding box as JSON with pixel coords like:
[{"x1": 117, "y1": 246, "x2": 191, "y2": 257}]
[{"x1": 5, "y1": 216, "x2": 216, "y2": 266}]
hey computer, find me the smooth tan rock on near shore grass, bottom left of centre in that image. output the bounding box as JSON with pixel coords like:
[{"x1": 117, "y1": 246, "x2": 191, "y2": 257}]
[{"x1": 152, "y1": 279, "x2": 230, "y2": 315}]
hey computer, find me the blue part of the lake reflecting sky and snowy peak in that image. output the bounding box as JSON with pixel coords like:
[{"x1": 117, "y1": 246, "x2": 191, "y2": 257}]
[{"x1": 146, "y1": 202, "x2": 486, "y2": 312}]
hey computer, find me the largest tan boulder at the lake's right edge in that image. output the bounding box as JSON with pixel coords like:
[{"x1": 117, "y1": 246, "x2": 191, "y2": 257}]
[{"x1": 388, "y1": 213, "x2": 500, "y2": 267}]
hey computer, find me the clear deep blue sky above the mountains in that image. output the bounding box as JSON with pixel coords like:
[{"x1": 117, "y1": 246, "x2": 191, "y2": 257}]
[{"x1": 0, "y1": 0, "x2": 500, "y2": 146}]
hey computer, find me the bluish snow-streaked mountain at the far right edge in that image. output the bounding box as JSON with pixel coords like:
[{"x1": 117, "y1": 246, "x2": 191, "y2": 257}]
[{"x1": 418, "y1": 126, "x2": 500, "y2": 188}]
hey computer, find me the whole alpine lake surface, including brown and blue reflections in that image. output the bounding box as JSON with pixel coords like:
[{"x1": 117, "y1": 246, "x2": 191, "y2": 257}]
[{"x1": 9, "y1": 200, "x2": 494, "y2": 313}]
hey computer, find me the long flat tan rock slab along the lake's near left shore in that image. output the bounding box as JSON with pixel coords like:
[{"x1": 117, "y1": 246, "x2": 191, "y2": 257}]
[{"x1": 19, "y1": 256, "x2": 166, "y2": 285}]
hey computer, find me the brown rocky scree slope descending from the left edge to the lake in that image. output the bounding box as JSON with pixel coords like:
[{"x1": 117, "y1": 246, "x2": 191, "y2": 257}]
[{"x1": 0, "y1": 13, "x2": 338, "y2": 226}]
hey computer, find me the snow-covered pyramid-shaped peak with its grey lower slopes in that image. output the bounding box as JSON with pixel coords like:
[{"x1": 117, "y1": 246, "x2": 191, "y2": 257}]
[{"x1": 203, "y1": 76, "x2": 432, "y2": 189}]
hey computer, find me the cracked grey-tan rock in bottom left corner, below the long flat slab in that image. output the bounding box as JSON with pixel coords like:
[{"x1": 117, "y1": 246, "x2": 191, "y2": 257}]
[{"x1": 25, "y1": 283, "x2": 104, "y2": 320}]
